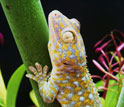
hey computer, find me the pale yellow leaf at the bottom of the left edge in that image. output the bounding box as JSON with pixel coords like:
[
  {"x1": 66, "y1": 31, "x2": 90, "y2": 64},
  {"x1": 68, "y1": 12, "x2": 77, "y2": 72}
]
[{"x1": 0, "y1": 70, "x2": 6, "y2": 104}]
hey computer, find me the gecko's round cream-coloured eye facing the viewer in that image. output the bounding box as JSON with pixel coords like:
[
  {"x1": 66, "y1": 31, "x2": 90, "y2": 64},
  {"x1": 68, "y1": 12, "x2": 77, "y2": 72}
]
[{"x1": 62, "y1": 31, "x2": 74, "y2": 43}]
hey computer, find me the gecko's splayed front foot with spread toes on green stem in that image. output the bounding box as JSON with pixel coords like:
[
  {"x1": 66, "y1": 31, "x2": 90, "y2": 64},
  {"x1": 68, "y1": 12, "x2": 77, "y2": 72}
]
[{"x1": 26, "y1": 63, "x2": 48, "y2": 83}]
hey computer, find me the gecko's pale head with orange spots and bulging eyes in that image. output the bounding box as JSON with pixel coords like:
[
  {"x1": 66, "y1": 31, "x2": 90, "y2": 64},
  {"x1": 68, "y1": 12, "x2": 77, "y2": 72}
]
[{"x1": 48, "y1": 10, "x2": 86, "y2": 69}]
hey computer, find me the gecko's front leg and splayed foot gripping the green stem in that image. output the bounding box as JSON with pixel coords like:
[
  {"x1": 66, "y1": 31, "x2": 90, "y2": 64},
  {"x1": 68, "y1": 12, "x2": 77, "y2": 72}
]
[{"x1": 26, "y1": 63, "x2": 58, "y2": 103}]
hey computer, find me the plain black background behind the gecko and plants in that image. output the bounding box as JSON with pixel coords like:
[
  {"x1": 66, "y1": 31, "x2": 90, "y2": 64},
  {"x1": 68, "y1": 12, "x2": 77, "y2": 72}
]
[{"x1": 0, "y1": 0, "x2": 124, "y2": 107}]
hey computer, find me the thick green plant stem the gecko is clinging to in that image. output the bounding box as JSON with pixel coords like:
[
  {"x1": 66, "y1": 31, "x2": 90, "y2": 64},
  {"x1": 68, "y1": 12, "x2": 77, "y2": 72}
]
[{"x1": 0, "y1": 0, "x2": 59, "y2": 107}]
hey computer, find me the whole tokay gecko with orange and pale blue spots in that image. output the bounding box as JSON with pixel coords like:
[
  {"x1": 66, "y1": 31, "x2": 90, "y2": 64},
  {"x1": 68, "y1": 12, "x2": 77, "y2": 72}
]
[{"x1": 26, "y1": 10, "x2": 102, "y2": 107}]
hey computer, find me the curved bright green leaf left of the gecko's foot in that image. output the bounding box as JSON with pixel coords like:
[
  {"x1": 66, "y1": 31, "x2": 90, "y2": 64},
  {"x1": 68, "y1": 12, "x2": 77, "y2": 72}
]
[{"x1": 6, "y1": 65, "x2": 25, "y2": 107}]
